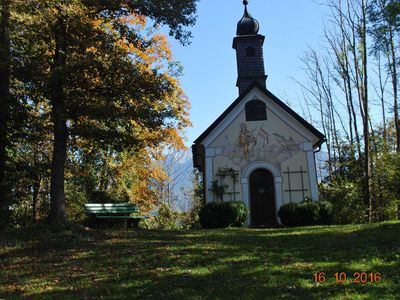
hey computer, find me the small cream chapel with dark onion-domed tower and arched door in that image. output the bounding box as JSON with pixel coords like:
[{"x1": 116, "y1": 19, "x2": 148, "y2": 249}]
[{"x1": 192, "y1": 1, "x2": 325, "y2": 227}]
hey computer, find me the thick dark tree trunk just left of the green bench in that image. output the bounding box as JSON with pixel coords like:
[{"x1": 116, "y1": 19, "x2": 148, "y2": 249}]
[{"x1": 48, "y1": 17, "x2": 68, "y2": 226}]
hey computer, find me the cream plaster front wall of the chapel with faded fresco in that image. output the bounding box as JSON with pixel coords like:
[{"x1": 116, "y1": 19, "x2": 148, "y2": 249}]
[{"x1": 208, "y1": 91, "x2": 311, "y2": 203}]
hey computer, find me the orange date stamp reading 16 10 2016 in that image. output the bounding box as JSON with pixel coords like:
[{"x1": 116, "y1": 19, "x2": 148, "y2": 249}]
[{"x1": 313, "y1": 272, "x2": 382, "y2": 284}]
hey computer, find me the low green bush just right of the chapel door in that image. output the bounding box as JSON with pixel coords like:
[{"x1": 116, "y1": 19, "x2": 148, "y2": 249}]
[{"x1": 278, "y1": 198, "x2": 332, "y2": 227}]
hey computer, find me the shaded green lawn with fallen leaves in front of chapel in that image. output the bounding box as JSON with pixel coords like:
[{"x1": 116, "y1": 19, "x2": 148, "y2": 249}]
[{"x1": 0, "y1": 222, "x2": 400, "y2": 300}]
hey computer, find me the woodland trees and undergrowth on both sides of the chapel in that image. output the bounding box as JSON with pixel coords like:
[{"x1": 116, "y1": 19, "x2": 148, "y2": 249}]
[{"x1": 0, "y1": 0, "x2": 400, "y2": 228}]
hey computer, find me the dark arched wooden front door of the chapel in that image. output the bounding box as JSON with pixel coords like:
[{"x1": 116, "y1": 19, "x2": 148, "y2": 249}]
[{"x1": 249, "y1": 169, "x2": 277, "y2": 227}]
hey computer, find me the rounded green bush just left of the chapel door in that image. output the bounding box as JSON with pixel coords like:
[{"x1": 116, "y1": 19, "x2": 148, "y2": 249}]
[{"x1": 199, "y1": 201, "x2": 248, "y2": 228}]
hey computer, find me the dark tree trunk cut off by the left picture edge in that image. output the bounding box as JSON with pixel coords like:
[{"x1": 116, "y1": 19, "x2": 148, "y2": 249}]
[{"x1": 0, "y1": 0, "x2": 11, "y2": 228}]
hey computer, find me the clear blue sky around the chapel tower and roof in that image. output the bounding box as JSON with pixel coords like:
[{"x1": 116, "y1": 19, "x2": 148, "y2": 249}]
[{"x1": 166, "y1": 0, "x2": 328, "y2": 146}]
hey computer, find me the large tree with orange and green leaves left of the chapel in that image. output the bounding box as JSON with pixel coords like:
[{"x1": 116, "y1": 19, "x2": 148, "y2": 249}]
[{"x1": 7, "y1": 0, "x2": 197, "y2": 225}]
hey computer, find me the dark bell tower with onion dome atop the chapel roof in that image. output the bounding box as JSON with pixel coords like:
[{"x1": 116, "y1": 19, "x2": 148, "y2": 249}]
[{"x1": 232, "y1": 0, "x2": 267, "y2": 95}]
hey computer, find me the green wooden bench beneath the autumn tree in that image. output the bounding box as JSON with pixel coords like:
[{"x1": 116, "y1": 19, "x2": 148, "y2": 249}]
[{"x1": 85, "y1": 203, "x2": 145, "y2": 227}]
